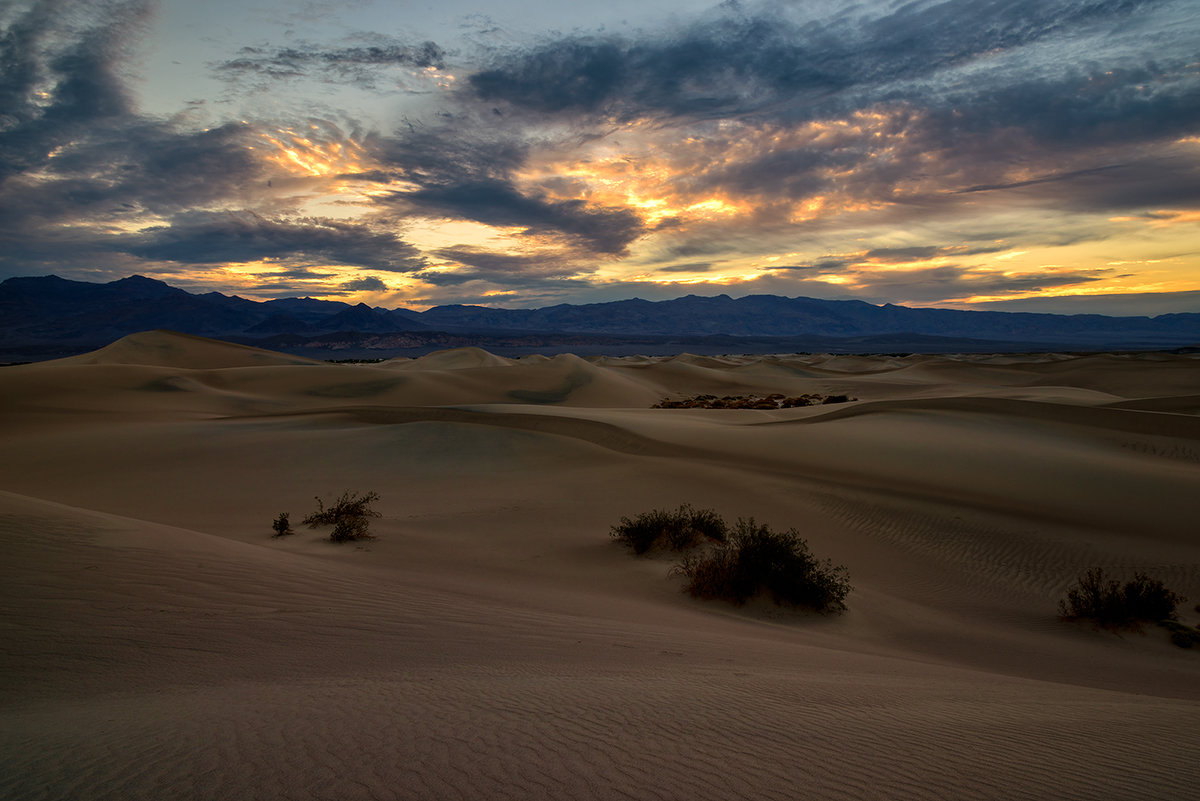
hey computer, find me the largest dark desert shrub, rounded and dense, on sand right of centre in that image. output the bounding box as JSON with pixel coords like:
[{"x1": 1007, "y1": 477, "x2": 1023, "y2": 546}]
[{"x1": 676, "y1": 518, "x2": 852, "y2": 613}]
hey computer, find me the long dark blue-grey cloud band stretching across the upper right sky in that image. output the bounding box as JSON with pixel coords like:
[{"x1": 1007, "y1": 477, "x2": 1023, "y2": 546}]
[{"x1": 469, "y1": 0, "x2": 1158, "y2": 118}]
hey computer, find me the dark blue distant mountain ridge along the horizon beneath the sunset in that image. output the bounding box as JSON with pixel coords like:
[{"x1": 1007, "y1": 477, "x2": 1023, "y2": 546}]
[{"x1": 0, "y1": 276, "x2": 1200, "y2": 362}]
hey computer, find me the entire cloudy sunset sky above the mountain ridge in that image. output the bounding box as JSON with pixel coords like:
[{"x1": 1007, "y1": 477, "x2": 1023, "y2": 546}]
[{"x1": 0, "y1": 0, "x2": 1200, "y2": 315}]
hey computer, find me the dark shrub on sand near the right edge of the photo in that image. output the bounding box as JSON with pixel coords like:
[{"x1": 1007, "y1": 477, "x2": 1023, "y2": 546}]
[{"x1": 1058, "y1": 567, "x2": 1186, "y2": 628}]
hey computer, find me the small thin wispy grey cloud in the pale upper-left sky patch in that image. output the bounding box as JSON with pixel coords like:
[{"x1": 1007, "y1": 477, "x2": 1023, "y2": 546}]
[{"x1": 215, "y1": 35, "x2": 445, "y2": 89}]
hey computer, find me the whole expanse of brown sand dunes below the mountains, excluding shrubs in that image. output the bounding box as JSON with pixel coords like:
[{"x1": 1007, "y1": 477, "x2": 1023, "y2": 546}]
[{"x1": 0, "y1": 332, "x2": 1200, "y2": 800}]
